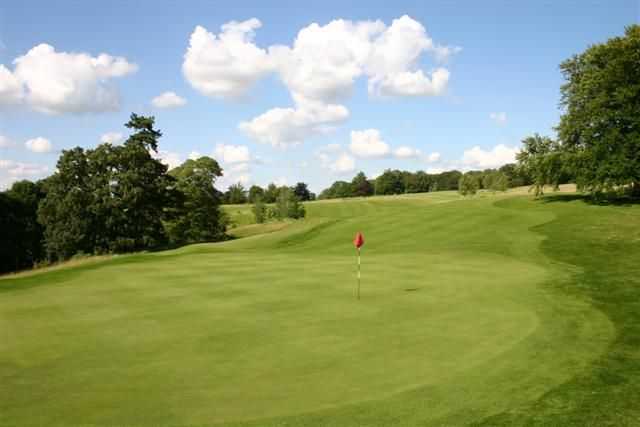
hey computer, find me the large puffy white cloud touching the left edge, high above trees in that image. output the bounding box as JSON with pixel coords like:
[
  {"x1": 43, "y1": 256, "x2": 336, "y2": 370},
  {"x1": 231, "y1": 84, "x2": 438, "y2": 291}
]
[{"x1": 0, "y1": 44, "x2": 138, "y2": 114}]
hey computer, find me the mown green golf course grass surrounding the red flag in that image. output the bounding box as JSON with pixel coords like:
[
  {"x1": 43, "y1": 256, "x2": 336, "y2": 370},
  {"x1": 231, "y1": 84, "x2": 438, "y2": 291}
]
[{"x1": 0, "y1": 192, "x2": 640, "y2": 426}]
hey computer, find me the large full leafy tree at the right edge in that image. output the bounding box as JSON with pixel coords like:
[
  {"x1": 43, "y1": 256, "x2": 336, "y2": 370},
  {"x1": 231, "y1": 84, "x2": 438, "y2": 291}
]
[{"x1": 558, "y1": 25, "x2": 640, "y2": 194}]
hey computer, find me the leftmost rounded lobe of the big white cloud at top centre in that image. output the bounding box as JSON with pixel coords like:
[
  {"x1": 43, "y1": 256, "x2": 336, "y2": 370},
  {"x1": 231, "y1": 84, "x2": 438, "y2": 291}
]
[{"x1": 182, "y1": 18, "x2": 274, "y2": 98}]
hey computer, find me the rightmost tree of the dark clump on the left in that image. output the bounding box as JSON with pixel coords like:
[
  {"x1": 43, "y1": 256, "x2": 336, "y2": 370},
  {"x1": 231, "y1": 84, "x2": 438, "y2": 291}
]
[{"x1": 167, "y1": 157, "x2": 226, "y2": 244}]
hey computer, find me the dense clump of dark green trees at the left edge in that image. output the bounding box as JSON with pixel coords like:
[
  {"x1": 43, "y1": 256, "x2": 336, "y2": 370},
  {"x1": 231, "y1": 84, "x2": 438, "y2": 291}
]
[{"x1": 0, "y1": 114, "x2": 227, "y2": 272}]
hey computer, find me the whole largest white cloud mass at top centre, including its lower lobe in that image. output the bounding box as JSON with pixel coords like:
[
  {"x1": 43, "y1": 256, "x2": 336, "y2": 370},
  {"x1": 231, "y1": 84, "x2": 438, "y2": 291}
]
[{"x1": 188, "y1": 15, "x2": 460, "y2": 147}]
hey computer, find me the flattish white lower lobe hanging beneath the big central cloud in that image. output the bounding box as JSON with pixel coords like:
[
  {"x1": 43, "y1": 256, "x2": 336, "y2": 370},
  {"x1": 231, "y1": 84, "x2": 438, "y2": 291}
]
[{"x1": 238, "y1": 102, "x2": 349, "y2": 148}]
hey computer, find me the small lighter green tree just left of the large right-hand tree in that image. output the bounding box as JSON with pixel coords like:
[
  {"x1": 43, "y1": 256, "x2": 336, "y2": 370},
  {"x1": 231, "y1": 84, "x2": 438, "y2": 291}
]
[{"x1": 516, "y1": 134, "x2": 566, "y2": 196}]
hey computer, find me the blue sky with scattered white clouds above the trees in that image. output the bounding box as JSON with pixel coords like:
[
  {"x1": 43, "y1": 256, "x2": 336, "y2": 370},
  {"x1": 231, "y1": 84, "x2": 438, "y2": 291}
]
[{"x1": 0, "y1": 0, "x2": 640, "y2": 192}]
